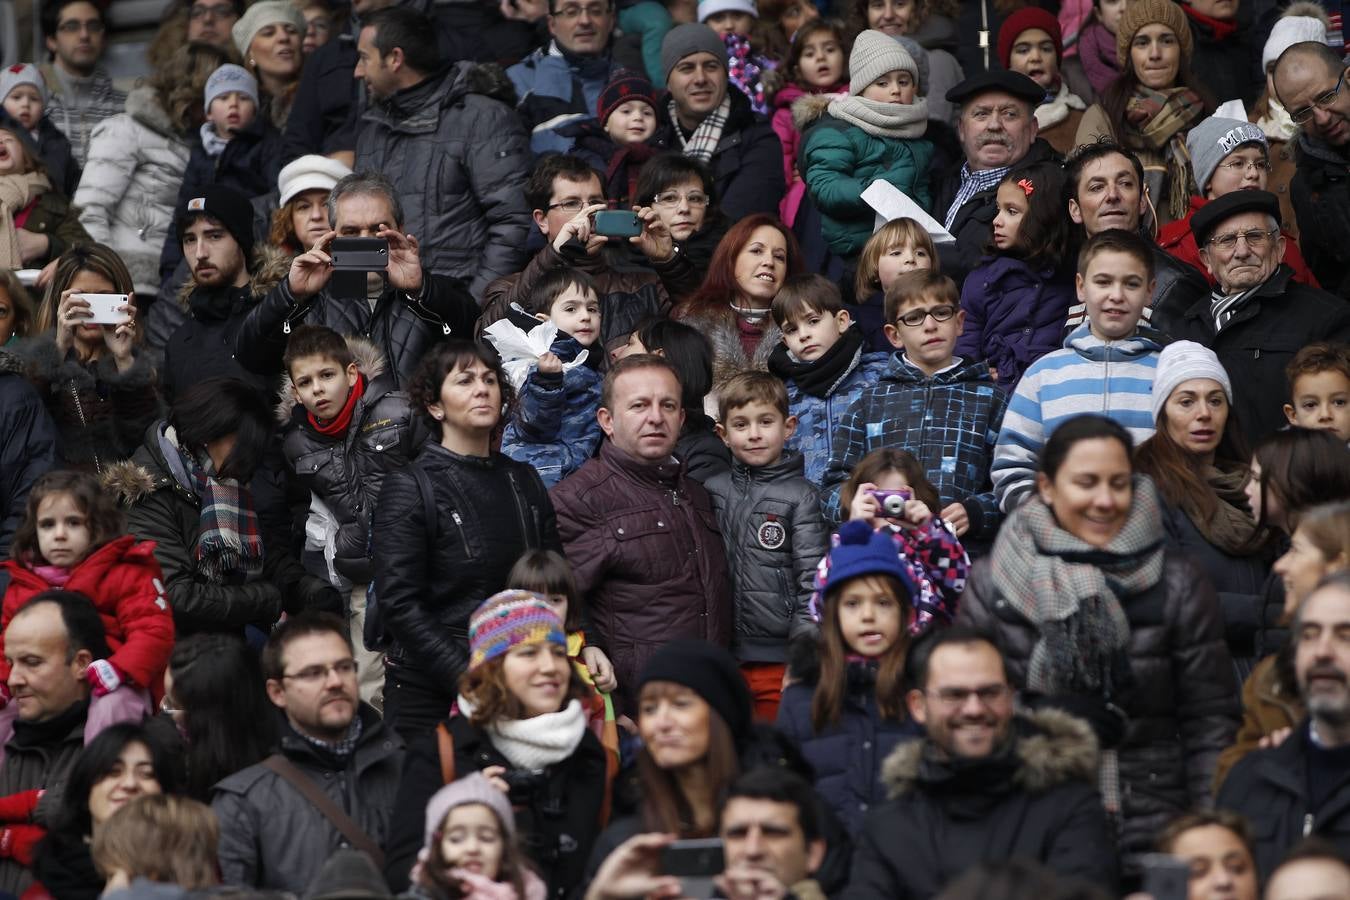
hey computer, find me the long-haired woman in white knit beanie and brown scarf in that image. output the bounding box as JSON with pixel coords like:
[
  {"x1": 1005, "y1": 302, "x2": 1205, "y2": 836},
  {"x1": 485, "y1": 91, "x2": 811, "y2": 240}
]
[{"x1": 1134, "y1": 340, "x2": 1272, "y2": 671}]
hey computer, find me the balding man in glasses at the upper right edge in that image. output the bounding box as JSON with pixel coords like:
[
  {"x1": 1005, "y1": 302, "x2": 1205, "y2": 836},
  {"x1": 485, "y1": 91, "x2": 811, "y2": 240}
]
[{"x1": 1270, "y1": 40, "x2": 1350, "y2": 297}]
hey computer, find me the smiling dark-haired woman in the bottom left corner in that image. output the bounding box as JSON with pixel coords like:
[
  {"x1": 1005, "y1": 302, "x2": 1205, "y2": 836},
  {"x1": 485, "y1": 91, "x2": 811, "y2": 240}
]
[{"x1": 32, "y1": 723, "x2": 178, "y2": 900}]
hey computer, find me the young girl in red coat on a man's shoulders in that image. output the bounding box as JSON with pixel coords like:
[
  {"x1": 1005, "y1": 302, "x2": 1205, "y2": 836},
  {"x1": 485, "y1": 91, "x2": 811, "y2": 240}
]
[{"x1": 0, "y1": 471, "x2": 174, "y2": 739}]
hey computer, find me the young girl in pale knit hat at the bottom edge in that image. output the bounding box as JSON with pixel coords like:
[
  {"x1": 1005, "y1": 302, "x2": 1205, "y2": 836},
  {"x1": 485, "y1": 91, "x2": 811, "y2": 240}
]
[{"x1": 408, "y1": 772, "x2": 548, "y2": 900}]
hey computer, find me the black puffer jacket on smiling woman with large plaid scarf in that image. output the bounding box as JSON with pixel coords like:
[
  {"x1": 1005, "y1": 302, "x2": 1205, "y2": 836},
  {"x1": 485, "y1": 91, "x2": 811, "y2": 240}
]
[{"x1": 956, "y1": 552, "x2": 1239, "y2": 853}]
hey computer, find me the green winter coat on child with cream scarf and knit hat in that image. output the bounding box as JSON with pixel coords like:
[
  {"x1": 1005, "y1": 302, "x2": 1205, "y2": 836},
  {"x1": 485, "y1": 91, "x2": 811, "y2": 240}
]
[{"x1": 792, "y1": 94, "x2": 933, "y2": 258}]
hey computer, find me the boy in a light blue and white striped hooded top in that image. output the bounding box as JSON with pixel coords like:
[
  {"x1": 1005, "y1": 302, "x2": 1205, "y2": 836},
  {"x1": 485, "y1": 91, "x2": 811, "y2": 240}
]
[{"x1": 992, "y1": 228, "x2": 1164, "y2": 513}]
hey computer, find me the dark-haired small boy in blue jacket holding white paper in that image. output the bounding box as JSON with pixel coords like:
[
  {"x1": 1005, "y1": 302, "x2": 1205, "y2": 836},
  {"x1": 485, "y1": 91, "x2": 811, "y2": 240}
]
[{"x1": 494, "y1": 267, "x2": 605, "y2": 487}]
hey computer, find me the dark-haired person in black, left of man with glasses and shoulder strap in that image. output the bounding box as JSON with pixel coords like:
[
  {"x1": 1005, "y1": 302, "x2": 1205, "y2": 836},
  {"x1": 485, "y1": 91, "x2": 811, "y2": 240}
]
[{"x1": 159, "y1": 634, "x2": 277, "y2": 803}]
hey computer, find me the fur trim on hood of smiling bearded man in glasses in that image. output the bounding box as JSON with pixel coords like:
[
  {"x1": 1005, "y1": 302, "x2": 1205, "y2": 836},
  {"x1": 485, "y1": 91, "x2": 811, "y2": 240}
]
[{"x1": 882, "y1": 710, "x2": 1098, "y2": 799}]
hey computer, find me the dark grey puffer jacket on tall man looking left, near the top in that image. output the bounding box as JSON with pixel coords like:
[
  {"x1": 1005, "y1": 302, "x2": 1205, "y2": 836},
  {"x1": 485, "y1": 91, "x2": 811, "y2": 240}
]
[{"x1": 355, "y1": 62, "x2": 531, "y2": 297}]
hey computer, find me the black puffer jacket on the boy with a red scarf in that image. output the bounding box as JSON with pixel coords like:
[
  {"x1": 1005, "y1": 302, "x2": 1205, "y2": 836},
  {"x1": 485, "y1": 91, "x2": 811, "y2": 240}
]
[{"x1": 277, "y1": 337, "x2": 429, "y2": 584}]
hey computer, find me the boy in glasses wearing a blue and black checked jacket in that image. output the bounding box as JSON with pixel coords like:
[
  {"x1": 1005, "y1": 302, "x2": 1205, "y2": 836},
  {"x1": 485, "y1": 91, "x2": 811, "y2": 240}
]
[{"x1": 822, "y1": 269, "x2": 1007, "y2": 549}]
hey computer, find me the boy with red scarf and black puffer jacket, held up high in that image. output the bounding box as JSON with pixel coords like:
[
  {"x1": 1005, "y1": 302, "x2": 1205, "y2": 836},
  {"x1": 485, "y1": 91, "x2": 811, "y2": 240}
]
[{"x1": 281, "y1": 325, "x2": 429, "y2": 706}]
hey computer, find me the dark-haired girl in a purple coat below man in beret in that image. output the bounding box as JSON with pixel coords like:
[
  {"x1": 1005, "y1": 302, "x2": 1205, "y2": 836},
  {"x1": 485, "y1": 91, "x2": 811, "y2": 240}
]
[{"x1": 956, "y1": 162, "x2": 1075, "y2": 393}]
